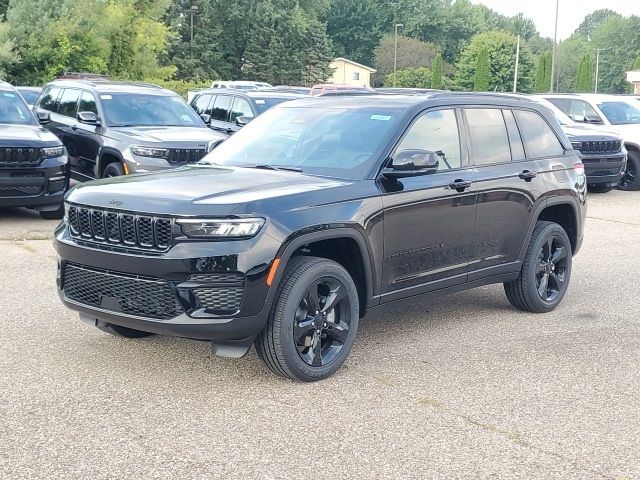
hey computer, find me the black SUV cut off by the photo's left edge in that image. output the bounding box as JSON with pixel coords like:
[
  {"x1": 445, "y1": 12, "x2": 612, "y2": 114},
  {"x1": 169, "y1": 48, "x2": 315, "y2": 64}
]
[{"x1": 0, "y1": 82, "x2": 69, "y2": 218}]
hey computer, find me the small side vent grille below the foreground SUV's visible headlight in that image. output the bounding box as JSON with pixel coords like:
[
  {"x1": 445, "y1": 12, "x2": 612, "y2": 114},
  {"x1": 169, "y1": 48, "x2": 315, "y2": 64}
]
[{"x1": 189, "y1": 273, "x2": 245, "y2": 312}]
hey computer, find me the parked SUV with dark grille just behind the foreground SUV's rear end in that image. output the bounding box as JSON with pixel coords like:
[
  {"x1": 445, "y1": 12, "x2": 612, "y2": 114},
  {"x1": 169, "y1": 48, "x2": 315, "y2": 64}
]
[{"x1": 532, "y1": 96, "x2": 627, "y2": 193}]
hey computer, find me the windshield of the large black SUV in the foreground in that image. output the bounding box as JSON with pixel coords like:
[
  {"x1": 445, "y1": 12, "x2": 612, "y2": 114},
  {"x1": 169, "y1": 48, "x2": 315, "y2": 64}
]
[{"x1": 204, "y1": 107, "x2": 399, "y2": 179}]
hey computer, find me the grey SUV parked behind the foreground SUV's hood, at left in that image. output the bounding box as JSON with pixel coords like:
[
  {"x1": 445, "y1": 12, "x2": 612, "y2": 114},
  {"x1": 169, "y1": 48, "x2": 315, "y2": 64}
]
[{"x1": 35, "y1": 80, "x2": 225, "y2": 180}]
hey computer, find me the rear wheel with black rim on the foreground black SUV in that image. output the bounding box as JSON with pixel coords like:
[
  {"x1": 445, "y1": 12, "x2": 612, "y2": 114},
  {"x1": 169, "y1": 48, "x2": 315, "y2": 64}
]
[{"x1": 504, "y1": 222, "x2": 572, "y2": 313}]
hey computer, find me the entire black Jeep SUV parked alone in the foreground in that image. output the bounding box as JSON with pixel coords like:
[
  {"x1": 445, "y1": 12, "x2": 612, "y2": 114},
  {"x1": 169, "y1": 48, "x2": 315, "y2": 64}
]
[{"x1": 55, "y1": 93, "x2": 586, "y2": 381}]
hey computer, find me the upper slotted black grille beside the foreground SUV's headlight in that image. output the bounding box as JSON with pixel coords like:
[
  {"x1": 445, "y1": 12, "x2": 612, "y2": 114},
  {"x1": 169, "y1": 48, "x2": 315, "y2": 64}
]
[{"x1": 68, "y1": 205, "x2": 173, "y2": 251}]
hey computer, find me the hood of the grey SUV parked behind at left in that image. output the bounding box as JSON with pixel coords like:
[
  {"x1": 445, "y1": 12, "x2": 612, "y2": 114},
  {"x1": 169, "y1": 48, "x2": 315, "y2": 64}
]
[{"x1": 110, "y1": 127, "x2": 226, "y2": 144}]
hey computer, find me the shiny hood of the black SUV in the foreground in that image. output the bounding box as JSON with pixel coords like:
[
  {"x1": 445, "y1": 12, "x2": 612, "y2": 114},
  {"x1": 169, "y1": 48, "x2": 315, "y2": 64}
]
[{"x1": 67, "y1": 165, "x2": 353, "y2": 216}]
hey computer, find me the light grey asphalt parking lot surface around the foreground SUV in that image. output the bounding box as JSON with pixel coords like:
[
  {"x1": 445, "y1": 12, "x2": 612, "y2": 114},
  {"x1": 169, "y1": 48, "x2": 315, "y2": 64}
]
[{"x1": 0, "y1": 191, "x2": 640, "y2": 479}]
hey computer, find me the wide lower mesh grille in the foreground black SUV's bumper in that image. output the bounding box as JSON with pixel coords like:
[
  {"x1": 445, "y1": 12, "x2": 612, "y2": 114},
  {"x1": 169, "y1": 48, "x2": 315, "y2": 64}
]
[{"x1": 62, "y1": 264, "x2": 183, "y2": 320}]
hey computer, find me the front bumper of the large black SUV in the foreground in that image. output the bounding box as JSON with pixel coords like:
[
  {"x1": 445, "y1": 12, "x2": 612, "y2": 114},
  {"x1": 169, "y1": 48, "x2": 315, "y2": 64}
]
[{"x1": 54, "y1": 224, "x2": 279, "y2": 344}]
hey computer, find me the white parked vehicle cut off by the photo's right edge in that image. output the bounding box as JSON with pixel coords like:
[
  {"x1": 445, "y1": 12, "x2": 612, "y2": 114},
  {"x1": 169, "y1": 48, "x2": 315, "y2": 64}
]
[{"x1": 543, "y1": 94, "x2": 640, "y2": 190}]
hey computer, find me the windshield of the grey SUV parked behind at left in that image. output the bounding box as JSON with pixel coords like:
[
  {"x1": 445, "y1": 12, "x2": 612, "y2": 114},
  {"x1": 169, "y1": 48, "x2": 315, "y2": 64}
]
[{"x1": 100, "y1": 93, "x2": 206, "y2": 128}]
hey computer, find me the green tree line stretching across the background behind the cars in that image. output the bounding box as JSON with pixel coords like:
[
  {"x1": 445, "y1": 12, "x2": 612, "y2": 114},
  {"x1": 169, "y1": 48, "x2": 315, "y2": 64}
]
[{"x1": 0, "y1": 0, "x2": 640, "y2": 92}]
